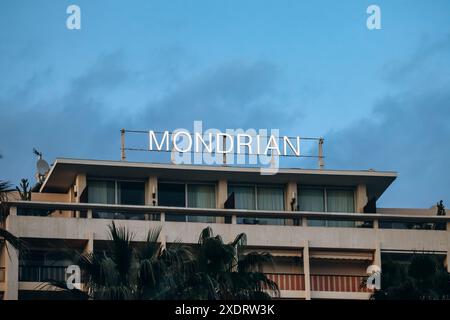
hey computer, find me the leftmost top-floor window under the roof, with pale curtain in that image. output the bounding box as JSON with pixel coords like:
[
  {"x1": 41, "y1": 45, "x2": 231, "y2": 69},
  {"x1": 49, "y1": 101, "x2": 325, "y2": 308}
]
[{"x1": 88, "y1": 180, "x2": 145, "y2": 205}]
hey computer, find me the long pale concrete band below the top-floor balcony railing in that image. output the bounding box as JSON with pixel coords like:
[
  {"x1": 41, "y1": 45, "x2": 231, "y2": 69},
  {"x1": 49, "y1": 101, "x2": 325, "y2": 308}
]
[{"x1": 8, "y1": 216, "x2": 448, "y2": 252}]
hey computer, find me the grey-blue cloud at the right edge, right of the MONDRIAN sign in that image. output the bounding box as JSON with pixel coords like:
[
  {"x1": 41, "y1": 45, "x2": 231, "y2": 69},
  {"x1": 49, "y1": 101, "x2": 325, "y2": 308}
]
[{"x1": 326, "y1": 38, "x2": 450, "y2": 207}]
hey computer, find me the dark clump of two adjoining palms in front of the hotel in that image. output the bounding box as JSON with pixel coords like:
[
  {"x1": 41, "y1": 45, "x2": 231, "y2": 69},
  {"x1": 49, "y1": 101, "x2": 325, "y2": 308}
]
[{"x1": 52, "y1": 222, "x2": 279, "y2": 300}]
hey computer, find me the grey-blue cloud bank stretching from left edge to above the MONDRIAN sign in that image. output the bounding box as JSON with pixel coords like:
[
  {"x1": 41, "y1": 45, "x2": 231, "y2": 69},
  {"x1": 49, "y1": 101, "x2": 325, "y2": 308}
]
[{"x1": 0, "y1": 51, "x2": 298, "y2": 183}]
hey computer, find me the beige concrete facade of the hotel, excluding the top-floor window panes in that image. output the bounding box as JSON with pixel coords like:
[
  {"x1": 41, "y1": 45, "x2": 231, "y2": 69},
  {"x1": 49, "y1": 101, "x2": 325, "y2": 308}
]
[{"x1": 0, "y1": 159, "x2": 450, "y2": 300}]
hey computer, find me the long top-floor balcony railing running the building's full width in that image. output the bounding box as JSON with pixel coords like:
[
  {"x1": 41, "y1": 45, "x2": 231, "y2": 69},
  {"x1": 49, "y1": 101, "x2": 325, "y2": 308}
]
[{"x1": 8, "y1": 201, "x2": 450, "y2": 230}]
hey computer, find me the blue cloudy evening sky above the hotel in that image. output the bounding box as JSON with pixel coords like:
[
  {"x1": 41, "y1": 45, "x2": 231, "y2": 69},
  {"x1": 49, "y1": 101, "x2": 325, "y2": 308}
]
[{"x1": 0, "y1": 0, "x2": 450, "y2": 207}]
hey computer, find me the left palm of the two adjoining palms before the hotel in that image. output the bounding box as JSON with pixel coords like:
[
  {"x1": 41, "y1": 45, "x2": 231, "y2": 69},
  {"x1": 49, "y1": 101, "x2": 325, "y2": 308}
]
[{"x1": 50, "y1": 222, "x2": 193, "y2": 300}]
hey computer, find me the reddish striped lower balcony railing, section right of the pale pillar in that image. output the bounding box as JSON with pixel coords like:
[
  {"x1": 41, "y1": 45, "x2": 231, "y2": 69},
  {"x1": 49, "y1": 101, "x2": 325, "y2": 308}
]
[{"x1": 311, "y1": 274, "x2": 370, "y2": 292}]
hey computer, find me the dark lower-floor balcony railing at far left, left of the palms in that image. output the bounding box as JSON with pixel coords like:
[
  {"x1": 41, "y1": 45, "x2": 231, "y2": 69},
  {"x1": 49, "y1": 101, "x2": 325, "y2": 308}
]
[{"x1": 19, "y1": 265, "x2": 67, "y2": 282}]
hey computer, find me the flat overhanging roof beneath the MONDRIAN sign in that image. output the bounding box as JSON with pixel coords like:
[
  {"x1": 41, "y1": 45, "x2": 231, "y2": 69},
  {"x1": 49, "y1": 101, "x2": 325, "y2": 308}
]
[{"x1": 40, "y1": 158, "x2": 397, "y2": 198}]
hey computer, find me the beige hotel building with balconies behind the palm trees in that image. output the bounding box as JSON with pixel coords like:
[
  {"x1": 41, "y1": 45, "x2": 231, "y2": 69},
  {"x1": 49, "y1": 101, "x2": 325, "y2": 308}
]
[{"x1": 0, "y1": 159, "x2": 450, "y2": 299}]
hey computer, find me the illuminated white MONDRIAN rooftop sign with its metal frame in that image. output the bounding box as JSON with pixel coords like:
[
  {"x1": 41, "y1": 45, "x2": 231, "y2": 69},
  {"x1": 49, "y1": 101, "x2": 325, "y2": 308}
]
[{"x1": 121, "y1": 121, "x2": 323, "y2": 174}]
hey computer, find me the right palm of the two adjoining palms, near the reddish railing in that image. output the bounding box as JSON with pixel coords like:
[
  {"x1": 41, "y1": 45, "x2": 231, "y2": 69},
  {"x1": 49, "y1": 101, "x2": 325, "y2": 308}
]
[{"x1": 178, "y1": 227, "x2": 279, "y2": 300}]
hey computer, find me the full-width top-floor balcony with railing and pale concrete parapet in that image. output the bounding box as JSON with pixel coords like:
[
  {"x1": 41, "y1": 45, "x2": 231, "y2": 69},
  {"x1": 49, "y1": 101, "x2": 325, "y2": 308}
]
[{"x1": 4, "y1": 201, "x2": 450, "y2": 254}]
